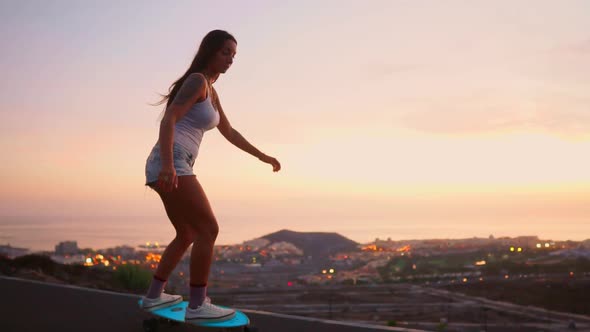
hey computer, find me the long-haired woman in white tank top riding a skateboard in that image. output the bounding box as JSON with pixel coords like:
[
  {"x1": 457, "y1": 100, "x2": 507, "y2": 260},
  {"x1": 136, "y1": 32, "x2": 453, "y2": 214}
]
[{"x1": 142, "y1": 30, "x2": 281, "y2": 322}]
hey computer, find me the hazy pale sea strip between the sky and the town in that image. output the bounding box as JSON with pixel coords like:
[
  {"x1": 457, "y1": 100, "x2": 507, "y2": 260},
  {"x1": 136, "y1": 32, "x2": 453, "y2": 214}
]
[{"x1": 0, "y1": 216, "x2": 590, "y2": 251}]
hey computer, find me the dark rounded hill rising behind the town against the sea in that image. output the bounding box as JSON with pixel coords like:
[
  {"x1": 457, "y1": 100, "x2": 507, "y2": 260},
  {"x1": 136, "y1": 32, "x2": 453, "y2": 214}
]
[{"x1": 262, "y1": 229, "x2": 359, "y2": 260}]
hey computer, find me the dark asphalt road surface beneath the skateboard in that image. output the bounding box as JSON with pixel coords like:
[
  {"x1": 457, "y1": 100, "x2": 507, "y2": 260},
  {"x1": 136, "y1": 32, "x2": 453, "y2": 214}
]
[{"x1": 0, "y1": 277, "x2": 426, "y2": 332}]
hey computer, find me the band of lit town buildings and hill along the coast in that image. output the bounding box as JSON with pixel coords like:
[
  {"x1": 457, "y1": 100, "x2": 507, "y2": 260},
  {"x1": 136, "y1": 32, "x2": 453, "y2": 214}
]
[{"x1": 0, "y1": 230, "x2": 590, "y2": 288}]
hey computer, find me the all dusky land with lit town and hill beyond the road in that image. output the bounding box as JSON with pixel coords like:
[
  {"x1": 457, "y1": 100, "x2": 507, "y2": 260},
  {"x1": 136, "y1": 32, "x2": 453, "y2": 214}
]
[{"x1": 0, "y1": 230, "x2": 590, "y2": 331}]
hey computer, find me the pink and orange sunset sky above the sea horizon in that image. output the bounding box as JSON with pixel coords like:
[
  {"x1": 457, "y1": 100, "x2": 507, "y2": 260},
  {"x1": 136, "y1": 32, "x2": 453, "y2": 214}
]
[{"x1": 0, "y1": 0, "x2": 590, "y2": 241}]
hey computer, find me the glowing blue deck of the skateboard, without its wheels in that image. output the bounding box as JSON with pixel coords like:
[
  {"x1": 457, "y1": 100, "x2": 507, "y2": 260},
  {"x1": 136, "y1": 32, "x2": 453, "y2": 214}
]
[{"x1": 139, "y1": 299, "x2": 253, "y2": 331}]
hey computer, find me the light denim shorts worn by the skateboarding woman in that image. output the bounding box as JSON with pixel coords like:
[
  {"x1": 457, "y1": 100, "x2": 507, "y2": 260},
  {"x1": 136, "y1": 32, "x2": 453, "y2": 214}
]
[{"x1": 145, "y1": 142, "x2": 197, "y2": 185}]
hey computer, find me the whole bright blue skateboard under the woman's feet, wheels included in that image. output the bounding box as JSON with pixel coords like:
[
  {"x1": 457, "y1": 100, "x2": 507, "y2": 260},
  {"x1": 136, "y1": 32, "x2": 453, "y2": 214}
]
[{"x1": 139, "y1": 299, "x2": 257, "y2": 332}]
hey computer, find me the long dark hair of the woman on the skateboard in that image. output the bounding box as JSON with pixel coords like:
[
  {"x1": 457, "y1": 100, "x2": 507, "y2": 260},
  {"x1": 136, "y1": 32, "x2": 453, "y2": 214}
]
[{"x1": 151, "y1": 30, "x2": 238, "y2": 108}]
